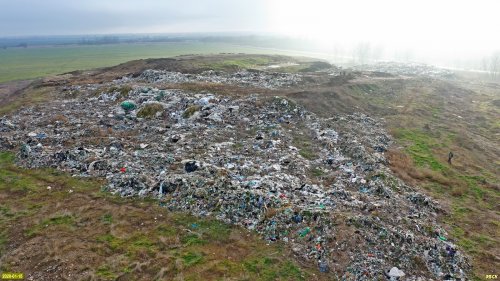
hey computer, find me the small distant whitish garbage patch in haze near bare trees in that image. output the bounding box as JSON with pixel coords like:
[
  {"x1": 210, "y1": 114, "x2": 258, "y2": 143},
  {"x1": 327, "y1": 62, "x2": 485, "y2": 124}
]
[{"x1": 353, "y1": 62, "x2": 454, "y2": 78}]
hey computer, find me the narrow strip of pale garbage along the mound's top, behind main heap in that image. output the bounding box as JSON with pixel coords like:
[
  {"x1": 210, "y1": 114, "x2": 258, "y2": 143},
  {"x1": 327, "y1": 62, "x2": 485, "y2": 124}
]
[{"x1": 139, "y1": 69, "x2": 301, "y2": 89}]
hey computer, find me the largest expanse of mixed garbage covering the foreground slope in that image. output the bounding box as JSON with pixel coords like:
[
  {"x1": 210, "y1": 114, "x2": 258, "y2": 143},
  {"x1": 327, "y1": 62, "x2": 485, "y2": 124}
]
[{"x1": 0, "y1": 68, "x2": 470, "y2": 280}]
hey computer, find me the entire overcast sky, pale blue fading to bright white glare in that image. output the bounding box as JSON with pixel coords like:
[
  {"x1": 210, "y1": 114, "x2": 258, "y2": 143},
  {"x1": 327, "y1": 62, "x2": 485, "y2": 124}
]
[{"x1": 0, "y1": 0, "x2": 500, "y2": 58}]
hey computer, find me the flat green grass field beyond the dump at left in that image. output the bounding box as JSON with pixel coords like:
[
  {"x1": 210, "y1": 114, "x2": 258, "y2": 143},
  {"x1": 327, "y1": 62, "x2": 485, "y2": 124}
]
[{"x1": 0, "y1": 42, "x2": 282, "y2": 83}]
